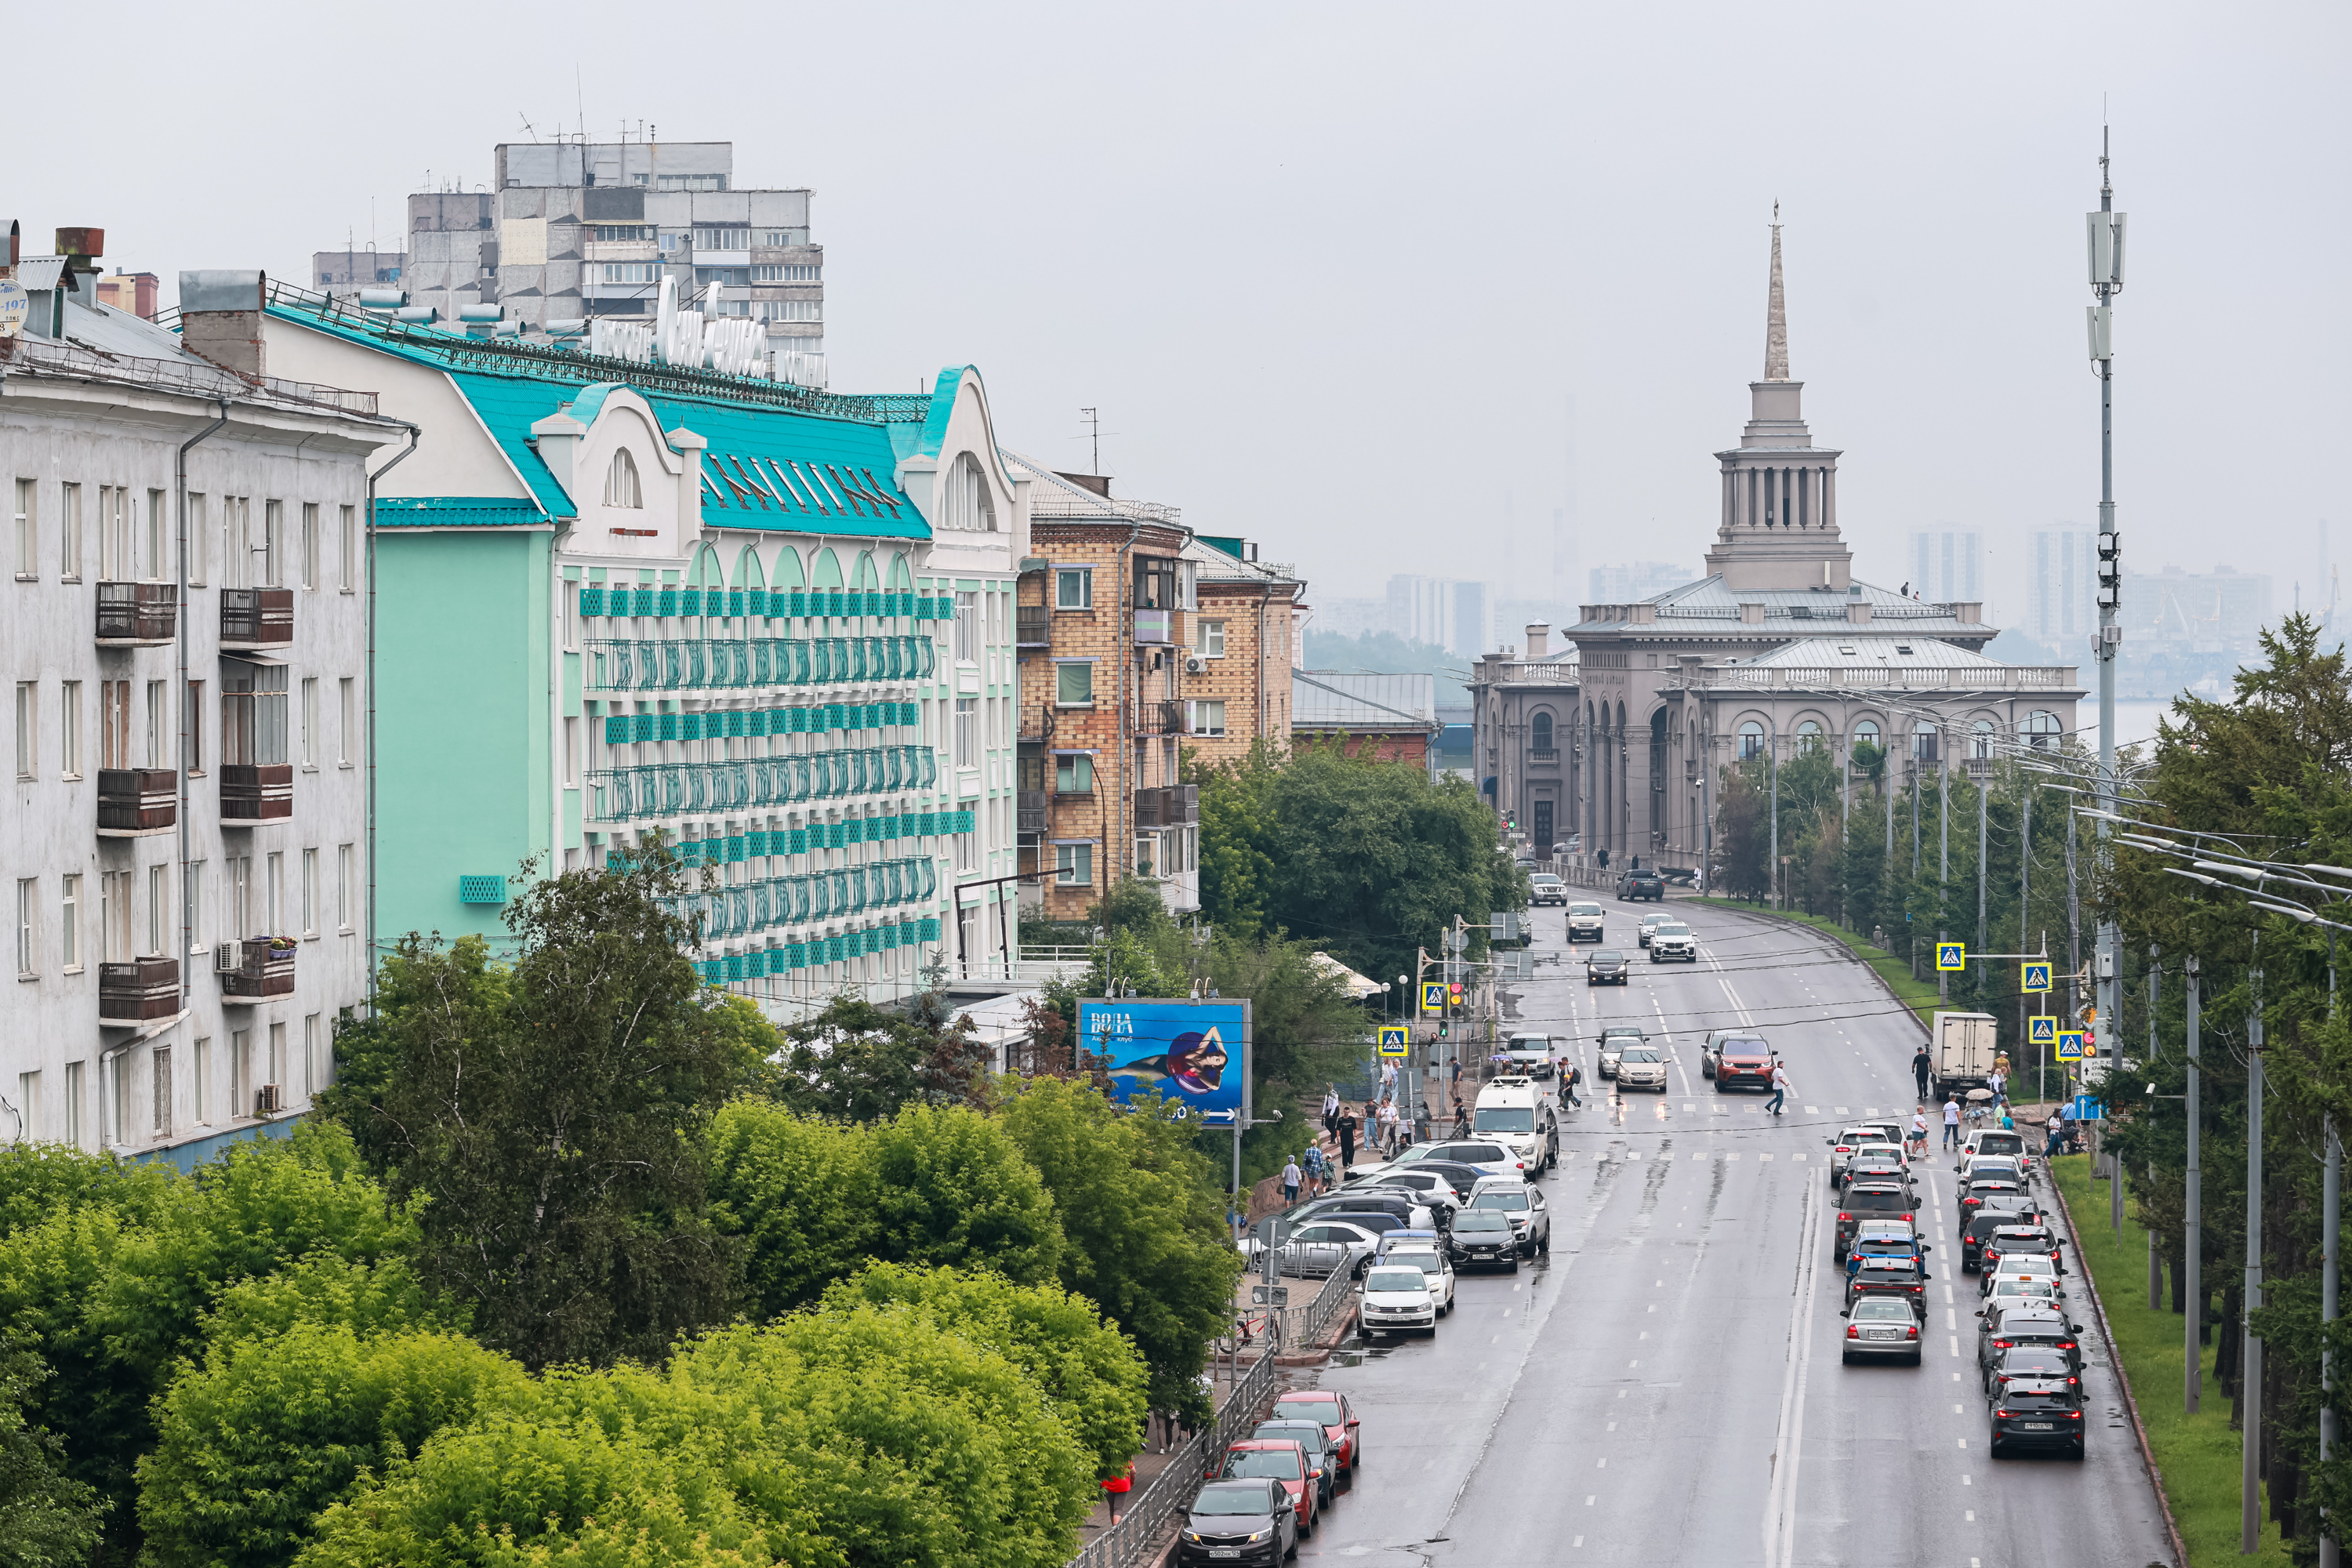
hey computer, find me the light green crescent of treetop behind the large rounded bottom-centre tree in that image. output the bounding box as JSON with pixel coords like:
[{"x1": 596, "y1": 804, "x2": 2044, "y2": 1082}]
[{"x1": 826, "y1": 1262, "x2": 1148, "y2": 1479}]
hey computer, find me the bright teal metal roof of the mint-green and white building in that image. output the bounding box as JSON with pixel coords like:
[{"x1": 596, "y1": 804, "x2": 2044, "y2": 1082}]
[{"x1": 268, "y1": 292, "x2": 936, "y2": 539}]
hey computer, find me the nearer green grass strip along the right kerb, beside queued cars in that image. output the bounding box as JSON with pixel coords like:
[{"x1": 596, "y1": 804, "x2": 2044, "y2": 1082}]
[{"x1": 2053, "y1": 1154, "x2": 2291, "y2": 1568}]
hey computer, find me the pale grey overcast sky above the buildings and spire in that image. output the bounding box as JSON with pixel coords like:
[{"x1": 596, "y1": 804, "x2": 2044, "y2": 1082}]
[{"x1": 0, "y1": 0, "x2": 2352, "y2": 623}]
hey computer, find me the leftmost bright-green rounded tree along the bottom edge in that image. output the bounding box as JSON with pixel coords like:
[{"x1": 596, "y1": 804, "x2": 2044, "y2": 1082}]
[{"x1": 139, "y1": 1323, "x2": 529, "y2": 1568}]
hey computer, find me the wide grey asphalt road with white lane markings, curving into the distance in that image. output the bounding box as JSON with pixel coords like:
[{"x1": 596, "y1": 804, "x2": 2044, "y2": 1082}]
[{"x1": 1301, "y1": 902, "x2": 2171, "y2": 1568}]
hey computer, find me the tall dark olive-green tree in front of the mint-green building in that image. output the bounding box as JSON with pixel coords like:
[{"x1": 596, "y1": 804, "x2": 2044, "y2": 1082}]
[{"x1": 358, "y1": 848, "x2": 774, "y2": 1366}]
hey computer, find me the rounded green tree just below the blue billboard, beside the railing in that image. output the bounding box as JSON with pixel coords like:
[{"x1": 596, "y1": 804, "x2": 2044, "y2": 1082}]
[{"x1": 1004, "y1": 1079, "x2": 1242, "y2": 1417}]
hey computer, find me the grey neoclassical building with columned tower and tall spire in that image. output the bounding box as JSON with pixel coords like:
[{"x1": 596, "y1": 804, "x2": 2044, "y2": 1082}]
[{"x1": 1470, "y1": 220, "x2": 2082, "y2": 867}]
